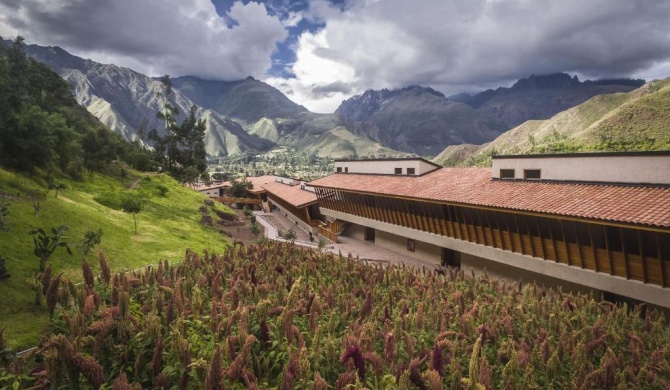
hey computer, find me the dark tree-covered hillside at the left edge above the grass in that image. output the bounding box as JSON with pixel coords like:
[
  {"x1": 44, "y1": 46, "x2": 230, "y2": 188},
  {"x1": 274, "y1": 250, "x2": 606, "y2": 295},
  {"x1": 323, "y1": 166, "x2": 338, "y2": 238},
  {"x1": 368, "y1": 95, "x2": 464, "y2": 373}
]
[{"x1": 0, "y1": 38, "x2": 150, "y2": 178}]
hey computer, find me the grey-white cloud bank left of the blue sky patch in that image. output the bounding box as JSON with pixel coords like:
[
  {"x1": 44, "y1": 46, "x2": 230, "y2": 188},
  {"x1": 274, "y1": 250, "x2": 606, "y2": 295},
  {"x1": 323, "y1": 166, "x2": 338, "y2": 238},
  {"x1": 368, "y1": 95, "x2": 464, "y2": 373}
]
[{"x1": 0, "y1": 0, "x2": 288, "y2": 79}]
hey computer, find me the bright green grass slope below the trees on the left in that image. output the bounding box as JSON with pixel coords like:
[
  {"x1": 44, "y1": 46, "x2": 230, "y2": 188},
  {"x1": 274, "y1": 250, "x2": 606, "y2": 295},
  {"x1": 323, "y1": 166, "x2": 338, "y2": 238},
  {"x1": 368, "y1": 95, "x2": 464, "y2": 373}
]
[{"x1": 0, "y1": 169, "x2": 235, "y2": 350}]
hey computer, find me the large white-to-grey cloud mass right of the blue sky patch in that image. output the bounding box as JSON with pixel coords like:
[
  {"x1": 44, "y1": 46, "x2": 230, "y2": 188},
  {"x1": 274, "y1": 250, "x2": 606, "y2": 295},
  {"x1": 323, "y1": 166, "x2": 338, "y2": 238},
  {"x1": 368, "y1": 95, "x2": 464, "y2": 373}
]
[{"x1": 269, "y1": 0, "x2": 670, "y2": 112}]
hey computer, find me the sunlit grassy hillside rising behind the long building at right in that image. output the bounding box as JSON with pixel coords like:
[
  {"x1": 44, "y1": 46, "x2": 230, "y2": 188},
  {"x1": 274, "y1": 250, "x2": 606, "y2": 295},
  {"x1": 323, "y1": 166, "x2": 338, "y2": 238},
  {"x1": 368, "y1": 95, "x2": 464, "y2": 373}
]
[{"x1": 434, "y1": 79, "x2": 670, "y2": 166}]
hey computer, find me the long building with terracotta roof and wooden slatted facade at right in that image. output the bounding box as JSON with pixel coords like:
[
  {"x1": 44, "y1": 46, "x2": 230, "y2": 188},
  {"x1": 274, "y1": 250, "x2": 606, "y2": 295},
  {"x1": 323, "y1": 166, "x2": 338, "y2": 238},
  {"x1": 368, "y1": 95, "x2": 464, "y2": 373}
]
[{"x1": 309, "y1": 152, "x2": 670, "y2": 308}]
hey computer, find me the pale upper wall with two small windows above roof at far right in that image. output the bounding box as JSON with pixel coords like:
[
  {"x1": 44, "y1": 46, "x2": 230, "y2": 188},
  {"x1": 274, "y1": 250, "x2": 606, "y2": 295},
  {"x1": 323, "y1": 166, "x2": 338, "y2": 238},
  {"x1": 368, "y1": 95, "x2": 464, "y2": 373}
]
[{"x1": 491, "y1": 155, "x2": 670, "y2": 184}]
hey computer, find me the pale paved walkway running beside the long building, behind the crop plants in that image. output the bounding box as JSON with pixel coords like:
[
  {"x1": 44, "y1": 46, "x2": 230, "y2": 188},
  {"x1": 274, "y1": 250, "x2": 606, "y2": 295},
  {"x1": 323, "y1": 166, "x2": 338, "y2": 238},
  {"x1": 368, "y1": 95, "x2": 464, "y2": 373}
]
[{"x1": 254, "y1": 211, "x2": 439, "y2": 270}]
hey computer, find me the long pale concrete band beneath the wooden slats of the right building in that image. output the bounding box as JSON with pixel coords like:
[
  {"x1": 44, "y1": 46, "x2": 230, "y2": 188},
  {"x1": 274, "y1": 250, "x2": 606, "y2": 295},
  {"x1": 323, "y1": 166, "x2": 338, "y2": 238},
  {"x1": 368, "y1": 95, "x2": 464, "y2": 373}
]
[{"x1": 321, "y1": 208, "x2": 670, "y2": 308}]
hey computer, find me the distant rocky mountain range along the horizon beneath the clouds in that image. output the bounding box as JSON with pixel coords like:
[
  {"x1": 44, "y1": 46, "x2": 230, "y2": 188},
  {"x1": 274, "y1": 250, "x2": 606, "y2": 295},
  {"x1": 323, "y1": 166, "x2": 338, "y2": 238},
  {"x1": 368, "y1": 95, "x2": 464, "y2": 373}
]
[{"x1": 21, "y1": 40, "x2": 648, "y2": 158}]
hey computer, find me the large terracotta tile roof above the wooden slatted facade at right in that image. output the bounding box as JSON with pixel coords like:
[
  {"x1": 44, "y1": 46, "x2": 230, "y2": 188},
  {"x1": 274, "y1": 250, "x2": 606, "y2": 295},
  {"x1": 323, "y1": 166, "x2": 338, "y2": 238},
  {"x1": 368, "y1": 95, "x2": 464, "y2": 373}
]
[{"x1": 309, "y1": 168, "x2": 670, "y2": 227}]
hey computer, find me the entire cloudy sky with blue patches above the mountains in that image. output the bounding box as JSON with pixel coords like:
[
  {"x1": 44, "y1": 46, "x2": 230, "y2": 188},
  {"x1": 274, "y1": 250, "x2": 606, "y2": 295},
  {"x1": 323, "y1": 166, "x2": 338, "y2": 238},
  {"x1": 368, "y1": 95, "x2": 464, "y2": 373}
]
[{"x1": 0, "y1": 0, "x2": 670, "y2": 112}]
